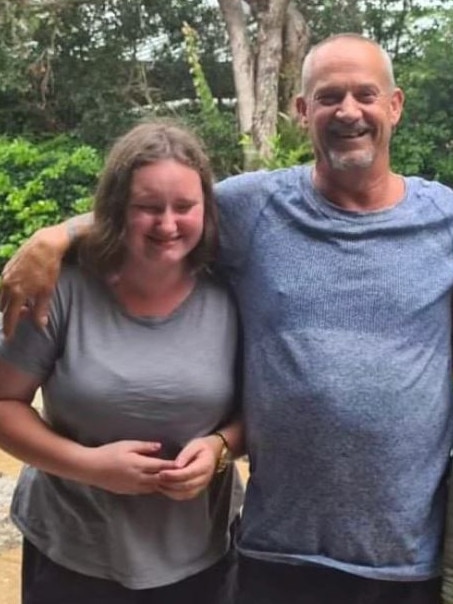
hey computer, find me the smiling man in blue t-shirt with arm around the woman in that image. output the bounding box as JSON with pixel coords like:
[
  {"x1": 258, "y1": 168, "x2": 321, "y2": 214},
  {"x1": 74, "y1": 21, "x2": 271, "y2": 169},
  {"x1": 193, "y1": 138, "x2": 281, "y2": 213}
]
[{"x1": 0, "y1": 34, "x2": 453, "y2": 604}]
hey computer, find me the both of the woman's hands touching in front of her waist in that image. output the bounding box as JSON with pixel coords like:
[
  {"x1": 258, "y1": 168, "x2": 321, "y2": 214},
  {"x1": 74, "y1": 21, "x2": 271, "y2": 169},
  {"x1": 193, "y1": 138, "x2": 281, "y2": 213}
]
[{"x1": 87, "y1": 436, "x2": 217, "y2": 501}]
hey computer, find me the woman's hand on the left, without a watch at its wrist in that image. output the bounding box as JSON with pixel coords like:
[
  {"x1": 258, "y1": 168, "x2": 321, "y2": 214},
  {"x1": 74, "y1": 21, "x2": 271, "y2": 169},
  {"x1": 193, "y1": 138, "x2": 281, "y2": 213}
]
[{"x1": 83, "y1": 440, "x2": 175, "y2": 495}]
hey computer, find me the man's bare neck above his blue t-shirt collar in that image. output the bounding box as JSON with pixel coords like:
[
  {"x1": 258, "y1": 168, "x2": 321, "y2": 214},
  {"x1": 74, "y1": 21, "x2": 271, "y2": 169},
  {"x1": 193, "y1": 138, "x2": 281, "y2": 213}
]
[{"x1": 313, "y1": 167, "x2": 405, "y2": 212}]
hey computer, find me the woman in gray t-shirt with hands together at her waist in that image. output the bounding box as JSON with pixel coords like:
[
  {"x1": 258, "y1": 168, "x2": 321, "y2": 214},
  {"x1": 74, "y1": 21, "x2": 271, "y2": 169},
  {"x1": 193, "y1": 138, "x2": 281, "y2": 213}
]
[{"x1": 0, "y1": 123, "x2": 241, "y2": 604}]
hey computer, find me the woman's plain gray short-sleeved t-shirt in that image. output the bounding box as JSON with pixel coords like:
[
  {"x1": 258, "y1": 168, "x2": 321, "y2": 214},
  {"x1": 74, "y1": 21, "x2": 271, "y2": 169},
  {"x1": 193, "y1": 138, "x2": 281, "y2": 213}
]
[{"x1": 0, "y1": 267, "x2": 240, "y2": 589}]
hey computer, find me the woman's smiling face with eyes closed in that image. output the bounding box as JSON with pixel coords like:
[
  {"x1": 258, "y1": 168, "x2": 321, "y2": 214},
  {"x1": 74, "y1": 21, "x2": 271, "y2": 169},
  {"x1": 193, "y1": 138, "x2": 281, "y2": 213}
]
[{"x1": 125, "y1": 159, "x2": 204, "y2": 267}]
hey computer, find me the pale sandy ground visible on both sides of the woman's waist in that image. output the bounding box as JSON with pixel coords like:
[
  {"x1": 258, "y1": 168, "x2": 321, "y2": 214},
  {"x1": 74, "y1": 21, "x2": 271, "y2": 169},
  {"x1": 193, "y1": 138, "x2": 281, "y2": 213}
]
[{"x1": 0, "y1": 392, "x2": 248, "y2": 604}]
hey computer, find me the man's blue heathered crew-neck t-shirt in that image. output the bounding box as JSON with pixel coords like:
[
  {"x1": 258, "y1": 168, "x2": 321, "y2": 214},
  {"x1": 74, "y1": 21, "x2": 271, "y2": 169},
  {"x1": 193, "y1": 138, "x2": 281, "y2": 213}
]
[{"x1": 217, "y1": 167, "x2": 453, "y2": 580}]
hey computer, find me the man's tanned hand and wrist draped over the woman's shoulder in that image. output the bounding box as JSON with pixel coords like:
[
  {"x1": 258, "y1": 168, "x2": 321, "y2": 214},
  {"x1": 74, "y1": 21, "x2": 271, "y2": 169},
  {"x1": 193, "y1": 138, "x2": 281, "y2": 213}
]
[{"x1": 0, "y1": 213, "x2": 93, "y2": 338}]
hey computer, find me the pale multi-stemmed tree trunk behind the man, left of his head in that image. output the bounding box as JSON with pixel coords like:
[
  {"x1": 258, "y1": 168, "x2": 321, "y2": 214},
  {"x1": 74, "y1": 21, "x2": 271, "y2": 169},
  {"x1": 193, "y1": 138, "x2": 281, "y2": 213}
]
[{"x1": 218, "y1": 0, "x2": 308, "y2": 169}]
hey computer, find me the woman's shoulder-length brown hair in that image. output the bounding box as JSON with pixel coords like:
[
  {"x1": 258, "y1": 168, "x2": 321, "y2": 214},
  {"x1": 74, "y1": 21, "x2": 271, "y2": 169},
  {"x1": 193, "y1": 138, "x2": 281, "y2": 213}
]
[{"x1": 79, "y1": 120, "x2": 218, "y2": 275}]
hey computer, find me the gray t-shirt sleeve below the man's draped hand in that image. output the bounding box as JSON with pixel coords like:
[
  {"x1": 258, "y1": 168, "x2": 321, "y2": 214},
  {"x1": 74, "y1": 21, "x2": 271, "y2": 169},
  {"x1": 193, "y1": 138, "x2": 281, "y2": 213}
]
[{"x1": 0, "y1": 272, "x2": 69, "y2": 382}]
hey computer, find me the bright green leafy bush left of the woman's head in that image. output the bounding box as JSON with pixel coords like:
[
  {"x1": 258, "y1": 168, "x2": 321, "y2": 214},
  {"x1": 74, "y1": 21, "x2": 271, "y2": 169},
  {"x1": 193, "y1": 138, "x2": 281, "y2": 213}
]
[{"x1": 0, "y1": 137, "x2": 101, "y2": 265}]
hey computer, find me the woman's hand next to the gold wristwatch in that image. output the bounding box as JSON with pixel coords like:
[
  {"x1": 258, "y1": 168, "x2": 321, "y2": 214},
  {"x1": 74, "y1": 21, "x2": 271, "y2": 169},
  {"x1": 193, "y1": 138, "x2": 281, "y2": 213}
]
[{"x1": 158, "y1": 435, "x2": 222, "y2": 501}]
